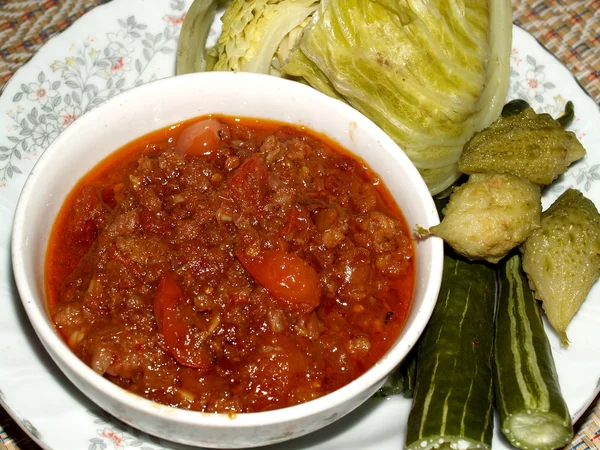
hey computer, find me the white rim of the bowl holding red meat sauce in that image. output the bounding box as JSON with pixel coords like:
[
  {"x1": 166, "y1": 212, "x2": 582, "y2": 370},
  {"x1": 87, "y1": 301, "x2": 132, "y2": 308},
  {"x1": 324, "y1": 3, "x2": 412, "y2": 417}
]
[{"x1": 11, "y1": 72, "x2": 443, "y2": 428}]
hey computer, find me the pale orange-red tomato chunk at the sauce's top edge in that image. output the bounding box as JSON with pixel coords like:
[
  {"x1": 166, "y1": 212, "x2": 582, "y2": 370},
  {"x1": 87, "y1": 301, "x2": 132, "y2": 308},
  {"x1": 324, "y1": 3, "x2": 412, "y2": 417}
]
[{"x1": 175, "y1": 119, "x2": 223, "y2": 158}]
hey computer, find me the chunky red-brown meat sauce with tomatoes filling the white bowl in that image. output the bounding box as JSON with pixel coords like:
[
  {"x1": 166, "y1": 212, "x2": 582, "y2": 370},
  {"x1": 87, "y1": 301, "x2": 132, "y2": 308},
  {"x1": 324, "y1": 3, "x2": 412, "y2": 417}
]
[{"x1": 46, "y1": 116, "x2": 415, "y2": 413}]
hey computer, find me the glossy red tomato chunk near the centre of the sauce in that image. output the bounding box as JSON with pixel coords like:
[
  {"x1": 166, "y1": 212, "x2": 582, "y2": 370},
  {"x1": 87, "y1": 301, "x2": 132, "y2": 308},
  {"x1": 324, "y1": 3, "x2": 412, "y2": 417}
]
[{"x1": 236, "y1": 250, "x2": 321, "y2": 312}]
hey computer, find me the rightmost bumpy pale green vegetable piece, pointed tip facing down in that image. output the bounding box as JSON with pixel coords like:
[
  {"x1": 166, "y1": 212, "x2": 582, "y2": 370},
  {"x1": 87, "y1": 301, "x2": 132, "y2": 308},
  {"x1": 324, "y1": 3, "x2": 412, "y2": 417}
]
[{"x1": 523, "y1": 189, "x2": 600, "y2": 346}]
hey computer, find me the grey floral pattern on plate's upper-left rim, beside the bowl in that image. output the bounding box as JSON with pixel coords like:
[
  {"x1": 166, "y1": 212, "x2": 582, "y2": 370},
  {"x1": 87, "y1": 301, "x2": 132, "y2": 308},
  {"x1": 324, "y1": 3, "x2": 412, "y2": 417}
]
[{"x1": 0, "y1": 0, "x2": 186, "y2": 187}]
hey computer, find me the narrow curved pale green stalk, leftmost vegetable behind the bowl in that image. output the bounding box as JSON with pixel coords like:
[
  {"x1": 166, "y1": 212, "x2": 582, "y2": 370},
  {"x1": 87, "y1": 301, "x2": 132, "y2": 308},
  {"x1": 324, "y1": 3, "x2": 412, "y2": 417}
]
[{"x1": 175, "y1": 0, "x2": 221, "y2": 75}]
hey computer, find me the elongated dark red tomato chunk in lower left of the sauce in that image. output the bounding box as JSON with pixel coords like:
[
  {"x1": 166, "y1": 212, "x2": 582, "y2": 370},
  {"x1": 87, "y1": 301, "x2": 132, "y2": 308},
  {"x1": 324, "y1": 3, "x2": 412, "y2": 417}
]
[{"x1": 154, "y1": 274, "x2": 212, "y2": 371}]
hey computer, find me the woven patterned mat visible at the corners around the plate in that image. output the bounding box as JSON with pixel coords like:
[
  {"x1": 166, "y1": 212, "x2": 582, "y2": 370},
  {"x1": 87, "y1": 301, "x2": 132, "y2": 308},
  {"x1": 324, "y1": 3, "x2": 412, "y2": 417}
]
[{"x1": 0, "y1": 0, "x2": 600, "y2": 450}]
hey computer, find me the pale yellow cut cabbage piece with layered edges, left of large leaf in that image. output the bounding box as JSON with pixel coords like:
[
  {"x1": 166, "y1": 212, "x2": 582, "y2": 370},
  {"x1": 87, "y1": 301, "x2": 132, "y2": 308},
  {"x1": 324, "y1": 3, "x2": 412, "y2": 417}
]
[{"x1": 213, "y1": 0, "x2": 319, "y2": 75}]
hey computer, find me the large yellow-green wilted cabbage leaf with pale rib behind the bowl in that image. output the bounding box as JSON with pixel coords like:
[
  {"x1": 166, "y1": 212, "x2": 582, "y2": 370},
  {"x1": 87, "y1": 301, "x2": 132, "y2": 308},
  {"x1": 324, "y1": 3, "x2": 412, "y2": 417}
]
[{"x1": 283, "y1": 0, "x2": 511, "y2": 194}]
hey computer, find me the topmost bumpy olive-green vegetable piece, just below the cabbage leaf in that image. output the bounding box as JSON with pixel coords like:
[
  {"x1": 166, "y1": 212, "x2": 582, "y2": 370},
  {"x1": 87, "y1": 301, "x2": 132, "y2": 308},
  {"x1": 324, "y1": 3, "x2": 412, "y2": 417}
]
[{"x1": 458, "y1": 108, "x2": 585, "y2": 185}]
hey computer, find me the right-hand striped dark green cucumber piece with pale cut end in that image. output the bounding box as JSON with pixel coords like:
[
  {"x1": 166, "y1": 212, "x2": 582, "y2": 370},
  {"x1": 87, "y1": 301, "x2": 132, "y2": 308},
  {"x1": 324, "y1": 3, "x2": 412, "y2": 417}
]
[{"x1": 494, "y1": 253, "x2": 573, "y2": 450}]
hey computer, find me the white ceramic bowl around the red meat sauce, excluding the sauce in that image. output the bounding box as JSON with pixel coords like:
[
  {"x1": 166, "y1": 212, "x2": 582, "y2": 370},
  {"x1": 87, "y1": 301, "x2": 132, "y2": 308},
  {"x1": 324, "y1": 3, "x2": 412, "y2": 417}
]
[{"x1": 12, "y1": 72, "x2": 443, "y2": 448}]
